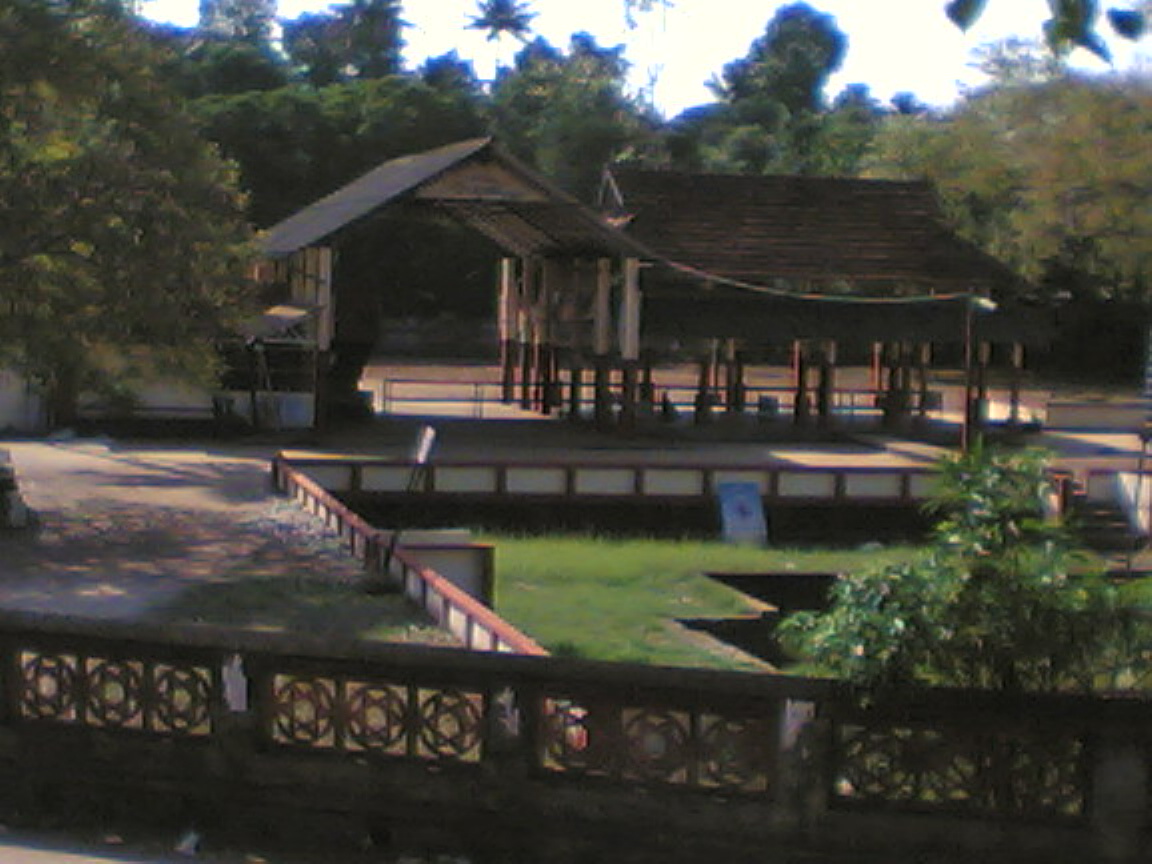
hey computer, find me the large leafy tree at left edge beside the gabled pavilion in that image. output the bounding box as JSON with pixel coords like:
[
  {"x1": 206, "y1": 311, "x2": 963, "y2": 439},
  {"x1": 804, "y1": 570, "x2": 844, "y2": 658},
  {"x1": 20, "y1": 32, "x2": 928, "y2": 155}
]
[{"x1": 0, "y1": 0, "x2": 249, "y2": 425}]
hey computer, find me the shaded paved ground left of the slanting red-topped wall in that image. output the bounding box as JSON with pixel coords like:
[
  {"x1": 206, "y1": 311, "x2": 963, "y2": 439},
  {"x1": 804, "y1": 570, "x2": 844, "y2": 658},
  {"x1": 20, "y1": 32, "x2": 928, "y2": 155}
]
[{"x1": 0, "y1": 439, "x2": 441, "y2": 641}]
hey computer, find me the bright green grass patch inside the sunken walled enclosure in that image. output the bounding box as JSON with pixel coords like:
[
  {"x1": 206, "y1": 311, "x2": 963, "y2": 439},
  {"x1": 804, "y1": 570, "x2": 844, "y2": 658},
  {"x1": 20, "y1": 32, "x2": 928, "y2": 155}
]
[{"x1": 483, "y1": 536, "x2": 917, "y2": 669}]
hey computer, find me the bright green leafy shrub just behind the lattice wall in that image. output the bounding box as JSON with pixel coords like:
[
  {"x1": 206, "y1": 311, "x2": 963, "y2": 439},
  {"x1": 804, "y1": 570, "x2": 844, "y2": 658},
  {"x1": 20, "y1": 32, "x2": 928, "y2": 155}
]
[{"x1": 781, "y1": 448, "x2": 1138, "y2": 692}]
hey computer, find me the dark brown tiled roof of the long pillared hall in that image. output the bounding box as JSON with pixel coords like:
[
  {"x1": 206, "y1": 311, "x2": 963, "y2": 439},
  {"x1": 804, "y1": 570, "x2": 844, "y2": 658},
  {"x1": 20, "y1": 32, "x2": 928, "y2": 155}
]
[{"x1": 604, "y1": 167, "x2": 1016, "y2": 290}]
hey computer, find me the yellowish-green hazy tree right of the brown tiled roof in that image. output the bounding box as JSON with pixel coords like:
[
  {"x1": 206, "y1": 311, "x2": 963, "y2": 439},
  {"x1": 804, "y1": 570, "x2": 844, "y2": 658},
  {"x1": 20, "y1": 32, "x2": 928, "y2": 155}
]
[{"x1": 867, "y1": 67, "x2": 1152, "y2": 302}]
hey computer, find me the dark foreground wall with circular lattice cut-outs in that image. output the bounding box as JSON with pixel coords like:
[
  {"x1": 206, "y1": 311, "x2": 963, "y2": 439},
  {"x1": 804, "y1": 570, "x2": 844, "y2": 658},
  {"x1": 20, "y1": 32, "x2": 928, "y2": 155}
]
[{"x1": 0, "y1": 612, "x2": 1152, "y2": 864}]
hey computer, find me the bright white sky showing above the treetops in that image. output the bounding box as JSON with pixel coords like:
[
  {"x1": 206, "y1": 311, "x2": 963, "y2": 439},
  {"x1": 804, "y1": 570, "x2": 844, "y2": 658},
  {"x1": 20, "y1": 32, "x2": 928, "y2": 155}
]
[{"x1": 142, "y1": 0, "x2": 1152, "y2": 116}]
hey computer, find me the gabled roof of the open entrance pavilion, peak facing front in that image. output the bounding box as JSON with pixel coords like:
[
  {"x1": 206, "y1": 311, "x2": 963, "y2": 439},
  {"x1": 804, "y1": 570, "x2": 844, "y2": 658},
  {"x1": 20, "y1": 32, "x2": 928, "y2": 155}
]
[{"x1": 260, "y1": 138, "x2": 642, "y2": 258}]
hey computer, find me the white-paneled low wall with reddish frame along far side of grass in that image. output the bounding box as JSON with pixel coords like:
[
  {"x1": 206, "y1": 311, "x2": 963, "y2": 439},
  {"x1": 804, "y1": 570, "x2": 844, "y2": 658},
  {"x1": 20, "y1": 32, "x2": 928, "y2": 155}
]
[{"x1": 282, "y1": 455, "x2": 935, "y2": 543}]
